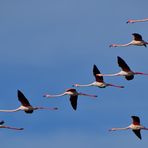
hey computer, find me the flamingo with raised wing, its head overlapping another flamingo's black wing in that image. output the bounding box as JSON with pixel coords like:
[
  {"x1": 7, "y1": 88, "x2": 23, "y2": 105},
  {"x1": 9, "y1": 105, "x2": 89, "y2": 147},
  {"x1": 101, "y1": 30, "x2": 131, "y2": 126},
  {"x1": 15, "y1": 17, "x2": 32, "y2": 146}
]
[{"x1": 97, "y1": 56, "x2": 148, "y2": 80}]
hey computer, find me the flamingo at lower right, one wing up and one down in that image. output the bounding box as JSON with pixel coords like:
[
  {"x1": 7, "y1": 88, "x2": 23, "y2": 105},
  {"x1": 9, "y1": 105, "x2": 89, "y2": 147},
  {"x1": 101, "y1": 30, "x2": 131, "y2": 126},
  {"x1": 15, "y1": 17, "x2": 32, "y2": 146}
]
[{"x1": 109, "y1": 116, "x2": 148, "y2": 139}]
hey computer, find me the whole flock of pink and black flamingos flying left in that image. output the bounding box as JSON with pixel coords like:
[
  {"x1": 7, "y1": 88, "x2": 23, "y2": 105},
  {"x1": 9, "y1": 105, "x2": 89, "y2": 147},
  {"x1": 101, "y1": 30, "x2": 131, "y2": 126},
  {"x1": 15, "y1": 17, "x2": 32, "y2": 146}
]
[{"x1": 0, "y1": 18, "x2": 148, "y2": 139}]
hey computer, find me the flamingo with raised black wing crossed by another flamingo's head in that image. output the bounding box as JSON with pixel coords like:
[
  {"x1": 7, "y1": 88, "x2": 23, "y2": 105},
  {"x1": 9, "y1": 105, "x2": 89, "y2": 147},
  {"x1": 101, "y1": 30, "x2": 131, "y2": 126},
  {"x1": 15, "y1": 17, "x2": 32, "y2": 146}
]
[{"x1": 73, "y1": 64, "x2": 124, "y2": 88}]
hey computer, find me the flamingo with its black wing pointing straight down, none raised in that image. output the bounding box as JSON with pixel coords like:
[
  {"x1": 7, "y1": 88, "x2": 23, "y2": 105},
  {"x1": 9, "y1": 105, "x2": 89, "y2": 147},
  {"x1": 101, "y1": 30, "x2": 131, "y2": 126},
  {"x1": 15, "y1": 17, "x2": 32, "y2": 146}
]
[{"x1": 43, "y1": 88, "x2": 97, "y2": 110}]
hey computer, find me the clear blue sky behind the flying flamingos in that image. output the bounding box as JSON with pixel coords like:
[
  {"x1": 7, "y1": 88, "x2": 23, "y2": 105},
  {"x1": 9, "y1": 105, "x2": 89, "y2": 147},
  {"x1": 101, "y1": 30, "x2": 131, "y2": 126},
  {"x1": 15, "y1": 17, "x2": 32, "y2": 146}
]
[{"x1": 0, "y1": 0, "x2": 148, "y2": 148}]
